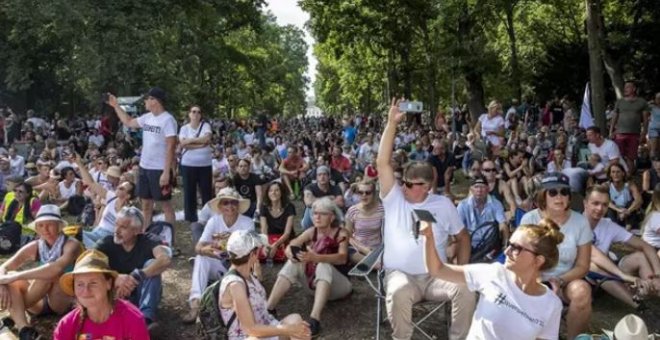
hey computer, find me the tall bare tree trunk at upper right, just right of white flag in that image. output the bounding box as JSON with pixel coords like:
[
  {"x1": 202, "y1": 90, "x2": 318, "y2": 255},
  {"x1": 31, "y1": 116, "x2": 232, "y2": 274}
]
[{"x1": 586, "y1": 0, "x2": 607, "y2": 133}]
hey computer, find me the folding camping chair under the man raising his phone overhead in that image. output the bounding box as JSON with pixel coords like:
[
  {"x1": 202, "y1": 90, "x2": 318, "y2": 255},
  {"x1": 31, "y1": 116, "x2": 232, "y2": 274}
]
[{"x1": 348, "y1": 245, "x2": 451, "y2": 340}]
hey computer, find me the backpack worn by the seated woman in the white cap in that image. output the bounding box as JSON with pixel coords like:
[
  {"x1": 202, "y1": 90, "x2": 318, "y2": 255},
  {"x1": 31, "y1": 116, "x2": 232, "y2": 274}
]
[{"x1": 197, "y1": 269, "x2": 250, "y2": 340}]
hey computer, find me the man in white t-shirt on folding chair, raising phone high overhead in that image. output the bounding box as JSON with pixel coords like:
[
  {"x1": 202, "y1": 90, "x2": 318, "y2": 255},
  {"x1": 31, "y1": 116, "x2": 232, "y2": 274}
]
[{"x1": 377, "y1": 100, "x2": 476, "y2": 340}]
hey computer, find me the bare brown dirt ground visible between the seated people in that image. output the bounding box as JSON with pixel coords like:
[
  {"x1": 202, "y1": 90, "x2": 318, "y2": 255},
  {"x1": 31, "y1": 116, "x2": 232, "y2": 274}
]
[{"x1": 3, "y1": 178, "x2": 660, "y2": 340}]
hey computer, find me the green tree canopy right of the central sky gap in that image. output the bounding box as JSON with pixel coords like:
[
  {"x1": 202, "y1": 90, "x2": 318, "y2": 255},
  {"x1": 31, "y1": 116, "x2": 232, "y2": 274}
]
[{"x1": 300, "y1": 0, "x2": 660, "y2": 120}]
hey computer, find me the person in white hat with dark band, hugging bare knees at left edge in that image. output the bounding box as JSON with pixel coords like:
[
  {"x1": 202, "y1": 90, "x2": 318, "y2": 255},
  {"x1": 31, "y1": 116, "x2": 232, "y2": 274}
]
[{"x1": 0, "y1": 204, "x2": 81, "y2": 339}]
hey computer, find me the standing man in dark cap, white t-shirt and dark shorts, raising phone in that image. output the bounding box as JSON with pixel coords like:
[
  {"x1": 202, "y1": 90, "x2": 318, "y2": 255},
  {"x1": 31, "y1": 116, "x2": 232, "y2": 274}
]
[{"x1": 108, "y1": 87, "x2": 177, "y2": 236}]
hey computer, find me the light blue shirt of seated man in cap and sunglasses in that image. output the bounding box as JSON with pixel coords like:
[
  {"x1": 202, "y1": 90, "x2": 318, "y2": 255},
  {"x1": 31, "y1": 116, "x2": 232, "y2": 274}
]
[{"x1": 458, "y1": 195, "x2": 506, "y2": 246}]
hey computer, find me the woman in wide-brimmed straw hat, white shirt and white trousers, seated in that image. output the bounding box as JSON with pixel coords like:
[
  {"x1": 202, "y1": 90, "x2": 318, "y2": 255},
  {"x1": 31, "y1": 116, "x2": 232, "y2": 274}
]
[{"x1": 183, "y1": 187, "x2": 254, "y2": 323}]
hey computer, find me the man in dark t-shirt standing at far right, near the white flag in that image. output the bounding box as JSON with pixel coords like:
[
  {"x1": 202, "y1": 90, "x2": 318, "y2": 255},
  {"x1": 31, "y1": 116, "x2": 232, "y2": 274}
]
[{"x1": 610, "y1": 81, "x2": 651, "y2": 173}]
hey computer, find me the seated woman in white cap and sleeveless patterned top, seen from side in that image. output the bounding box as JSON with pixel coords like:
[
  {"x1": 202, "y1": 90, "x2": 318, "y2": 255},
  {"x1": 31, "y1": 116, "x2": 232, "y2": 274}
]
[{"x1": 218, "y1": 230, "x2": 311, "y2": 340}]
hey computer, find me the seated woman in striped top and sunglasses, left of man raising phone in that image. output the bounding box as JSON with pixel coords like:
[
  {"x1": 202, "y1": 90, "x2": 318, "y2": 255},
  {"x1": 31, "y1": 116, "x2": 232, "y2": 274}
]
[{"x1": 345, "y1": 181, "x2": 385, "y2": 263}]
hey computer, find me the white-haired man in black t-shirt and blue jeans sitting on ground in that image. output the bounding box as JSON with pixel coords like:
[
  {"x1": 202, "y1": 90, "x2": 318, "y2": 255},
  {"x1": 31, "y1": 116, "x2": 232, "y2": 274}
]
[{"x1": 95, "y1": 207, "x2": 172, "y2": 332}]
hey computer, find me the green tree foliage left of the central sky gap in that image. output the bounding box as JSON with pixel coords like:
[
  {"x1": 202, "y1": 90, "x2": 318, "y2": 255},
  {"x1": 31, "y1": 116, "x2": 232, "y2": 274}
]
[{"x1": 0, "y1": 0, "x2": 308, "y2": 115}]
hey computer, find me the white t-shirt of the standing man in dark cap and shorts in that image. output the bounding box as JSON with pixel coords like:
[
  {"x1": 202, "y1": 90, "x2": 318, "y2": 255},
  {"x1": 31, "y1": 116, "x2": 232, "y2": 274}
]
[{"x1": 137, "y1": 111, "x2": 177, "y2": 170}]
